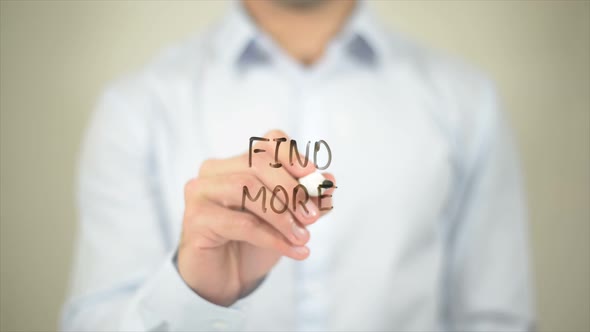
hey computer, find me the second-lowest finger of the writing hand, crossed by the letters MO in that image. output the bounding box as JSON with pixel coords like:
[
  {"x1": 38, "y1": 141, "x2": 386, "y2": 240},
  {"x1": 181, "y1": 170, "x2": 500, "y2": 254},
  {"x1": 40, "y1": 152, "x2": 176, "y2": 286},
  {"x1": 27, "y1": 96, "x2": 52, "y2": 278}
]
[{"x1": 185, "y1": 173, "x2": 309, "y2": 245}]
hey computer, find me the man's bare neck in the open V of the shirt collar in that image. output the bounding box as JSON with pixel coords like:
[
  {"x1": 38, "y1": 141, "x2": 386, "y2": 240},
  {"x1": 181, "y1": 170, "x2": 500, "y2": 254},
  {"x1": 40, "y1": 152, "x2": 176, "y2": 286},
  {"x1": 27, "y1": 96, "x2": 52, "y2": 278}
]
[{"x1": 244, "y1": 0, "x2": 355, "y2": 65}]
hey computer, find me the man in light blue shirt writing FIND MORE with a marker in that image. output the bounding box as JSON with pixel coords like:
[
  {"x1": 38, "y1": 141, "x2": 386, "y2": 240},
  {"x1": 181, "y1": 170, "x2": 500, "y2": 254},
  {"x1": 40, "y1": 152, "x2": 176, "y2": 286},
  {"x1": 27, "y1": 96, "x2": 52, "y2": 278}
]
[{"x1": 63, "y1": 0, "x2": 534, "y2": 331}]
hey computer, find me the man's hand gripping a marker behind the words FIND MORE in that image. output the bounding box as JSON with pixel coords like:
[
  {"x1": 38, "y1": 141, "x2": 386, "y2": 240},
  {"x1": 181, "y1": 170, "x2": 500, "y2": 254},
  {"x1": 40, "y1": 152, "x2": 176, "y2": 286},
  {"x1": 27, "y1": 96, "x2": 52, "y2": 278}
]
[{"x1": 178, "y1": 131, "x2": 334, "y2": 306}]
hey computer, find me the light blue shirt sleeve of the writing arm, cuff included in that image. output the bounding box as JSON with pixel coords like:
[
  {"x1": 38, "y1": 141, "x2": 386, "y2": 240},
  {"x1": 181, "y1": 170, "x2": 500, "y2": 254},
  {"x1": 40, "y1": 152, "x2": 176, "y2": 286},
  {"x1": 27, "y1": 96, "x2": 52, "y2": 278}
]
[{"x1": 61, "y1": 82, "x2": 244, "y2": 331}]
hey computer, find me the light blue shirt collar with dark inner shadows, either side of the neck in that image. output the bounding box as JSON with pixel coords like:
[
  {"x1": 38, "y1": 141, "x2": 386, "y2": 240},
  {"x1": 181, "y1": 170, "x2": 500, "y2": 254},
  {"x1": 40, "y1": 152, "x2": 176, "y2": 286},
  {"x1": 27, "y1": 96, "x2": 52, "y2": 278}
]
[{"x1": 215, "y1": 0, "x2": 384, "y2": 67}]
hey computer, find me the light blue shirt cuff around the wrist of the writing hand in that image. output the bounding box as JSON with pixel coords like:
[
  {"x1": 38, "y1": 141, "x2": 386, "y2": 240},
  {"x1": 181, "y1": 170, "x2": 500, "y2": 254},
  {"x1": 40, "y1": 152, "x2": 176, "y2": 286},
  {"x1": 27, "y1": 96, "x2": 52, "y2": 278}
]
[{"x1": 140, "y1": 253, "x2": 245, "y2": 331}]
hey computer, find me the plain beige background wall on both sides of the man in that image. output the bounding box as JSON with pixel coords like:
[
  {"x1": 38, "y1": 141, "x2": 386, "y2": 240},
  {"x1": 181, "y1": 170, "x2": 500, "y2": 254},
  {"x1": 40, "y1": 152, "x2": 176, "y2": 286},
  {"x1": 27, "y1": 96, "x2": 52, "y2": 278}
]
[{"x1": 0, "y1": 0, "x2": 590, "y2": 331}]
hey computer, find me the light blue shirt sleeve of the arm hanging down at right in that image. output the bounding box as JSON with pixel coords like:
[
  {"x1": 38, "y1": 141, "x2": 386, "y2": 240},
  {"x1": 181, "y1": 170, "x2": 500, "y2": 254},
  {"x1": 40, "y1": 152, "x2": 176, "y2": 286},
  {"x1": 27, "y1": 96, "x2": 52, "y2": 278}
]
[{"x1": 444, "y1": 84, "x2": 534, "y2": 331}]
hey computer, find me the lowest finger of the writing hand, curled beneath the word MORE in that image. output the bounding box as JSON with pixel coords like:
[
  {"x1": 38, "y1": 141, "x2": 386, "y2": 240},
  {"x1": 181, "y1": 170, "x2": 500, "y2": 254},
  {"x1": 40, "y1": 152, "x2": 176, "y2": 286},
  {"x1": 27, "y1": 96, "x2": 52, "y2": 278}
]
[{"x1": 196, "y1": 204, "x2": 309, "y2": 260}]
